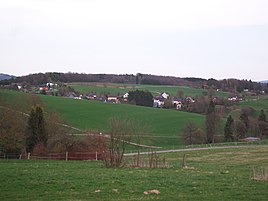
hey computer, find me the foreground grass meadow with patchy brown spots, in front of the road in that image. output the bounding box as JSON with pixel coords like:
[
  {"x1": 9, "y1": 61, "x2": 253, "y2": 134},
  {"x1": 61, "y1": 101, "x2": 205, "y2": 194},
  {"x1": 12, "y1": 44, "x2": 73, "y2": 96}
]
[{"x1": 0, "y1": 145, "x2": 268, "y2": 201}]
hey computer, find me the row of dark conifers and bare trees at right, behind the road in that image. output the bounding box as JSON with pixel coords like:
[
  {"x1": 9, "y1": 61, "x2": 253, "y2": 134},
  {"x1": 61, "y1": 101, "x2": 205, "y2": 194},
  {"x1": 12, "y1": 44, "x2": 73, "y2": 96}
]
[{"x1": 180, "y1": 100, "x2": 268, "y2": 144}]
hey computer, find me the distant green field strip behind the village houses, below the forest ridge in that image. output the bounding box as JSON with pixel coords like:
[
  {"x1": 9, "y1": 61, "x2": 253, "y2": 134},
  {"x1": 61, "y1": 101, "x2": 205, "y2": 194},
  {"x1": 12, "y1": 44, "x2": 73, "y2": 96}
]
[{"x1": 70, "y1": 83, "x2": 228, "y2": 97}]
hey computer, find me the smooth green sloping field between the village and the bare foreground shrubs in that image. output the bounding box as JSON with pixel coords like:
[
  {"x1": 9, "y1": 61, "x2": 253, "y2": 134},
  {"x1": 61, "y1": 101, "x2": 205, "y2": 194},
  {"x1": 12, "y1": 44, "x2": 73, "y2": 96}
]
[{"x1": 0, "y1": 90, "x2": 204, "y2": 147}]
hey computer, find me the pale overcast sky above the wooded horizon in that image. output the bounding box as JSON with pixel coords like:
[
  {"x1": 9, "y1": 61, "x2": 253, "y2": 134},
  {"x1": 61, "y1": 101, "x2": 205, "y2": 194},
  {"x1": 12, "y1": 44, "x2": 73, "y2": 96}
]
[{"x1": 0, "y1": 0, "x2": 268, "y2": 81}]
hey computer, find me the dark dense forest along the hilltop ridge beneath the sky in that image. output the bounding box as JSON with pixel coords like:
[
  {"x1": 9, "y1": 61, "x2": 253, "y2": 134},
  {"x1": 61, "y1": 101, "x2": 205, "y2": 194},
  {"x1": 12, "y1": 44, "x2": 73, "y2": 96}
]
[{"x1": 0, "y1": 72, "x2": 268, "y2": 94}]
